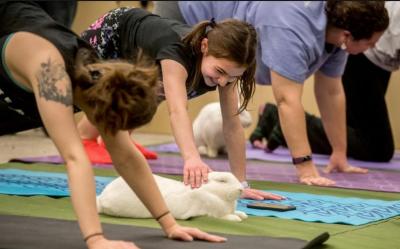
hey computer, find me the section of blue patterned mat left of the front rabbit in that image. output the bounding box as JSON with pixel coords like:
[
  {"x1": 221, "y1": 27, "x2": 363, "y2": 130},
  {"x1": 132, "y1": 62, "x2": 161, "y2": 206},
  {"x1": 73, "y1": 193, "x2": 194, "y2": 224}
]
[{"x1": 0, "y1": 169, "x2": 114, "y2": 197}]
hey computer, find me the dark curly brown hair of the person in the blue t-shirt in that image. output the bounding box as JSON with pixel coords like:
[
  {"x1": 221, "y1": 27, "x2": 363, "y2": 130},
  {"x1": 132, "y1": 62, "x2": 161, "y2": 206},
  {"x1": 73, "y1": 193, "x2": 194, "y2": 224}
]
[{"x1": 325, "y1": 0, "x2": 389, "y2": 40}]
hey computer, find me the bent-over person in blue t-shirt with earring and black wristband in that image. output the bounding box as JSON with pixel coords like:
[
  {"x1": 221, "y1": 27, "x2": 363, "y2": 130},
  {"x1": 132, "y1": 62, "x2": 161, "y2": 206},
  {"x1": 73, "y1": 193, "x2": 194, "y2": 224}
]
[{"x1": 154, "y1": 0, "x2": 389, "y2": 186}]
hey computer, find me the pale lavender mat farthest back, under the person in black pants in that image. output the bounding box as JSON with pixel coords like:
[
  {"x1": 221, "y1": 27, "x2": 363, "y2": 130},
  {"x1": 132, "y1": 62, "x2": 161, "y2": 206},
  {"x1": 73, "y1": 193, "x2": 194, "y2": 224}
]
[{"x1": 148, "y1": 143, "x2": 400, "y2": 170}]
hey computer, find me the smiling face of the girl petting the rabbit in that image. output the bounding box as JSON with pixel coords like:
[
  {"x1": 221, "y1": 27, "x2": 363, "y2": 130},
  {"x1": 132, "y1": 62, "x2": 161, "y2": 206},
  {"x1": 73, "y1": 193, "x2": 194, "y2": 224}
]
[{"x1": 201, "y1": 38, "x2": 246, "y2": 87}]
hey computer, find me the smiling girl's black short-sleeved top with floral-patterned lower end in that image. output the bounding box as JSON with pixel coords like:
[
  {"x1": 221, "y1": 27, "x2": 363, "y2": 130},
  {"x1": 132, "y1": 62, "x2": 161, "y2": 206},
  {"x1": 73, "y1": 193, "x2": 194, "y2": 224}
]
[{"x1": 82, "y1": 8, "x2": 216, "y2": 99}]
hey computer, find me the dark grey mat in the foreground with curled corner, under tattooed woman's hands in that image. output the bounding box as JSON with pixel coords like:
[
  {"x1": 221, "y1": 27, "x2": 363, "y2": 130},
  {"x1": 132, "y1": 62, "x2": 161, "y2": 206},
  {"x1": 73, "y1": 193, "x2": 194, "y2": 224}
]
[{"x1": 0, "y1": 215, "x2": 329, "y2": 249}]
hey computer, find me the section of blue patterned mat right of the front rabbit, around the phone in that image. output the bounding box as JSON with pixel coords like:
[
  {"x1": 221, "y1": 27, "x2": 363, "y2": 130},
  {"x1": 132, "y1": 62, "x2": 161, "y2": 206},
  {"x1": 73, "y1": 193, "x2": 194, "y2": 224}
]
[{"x1": 237, "y1": 190, "x2": 400, "y2": 225}]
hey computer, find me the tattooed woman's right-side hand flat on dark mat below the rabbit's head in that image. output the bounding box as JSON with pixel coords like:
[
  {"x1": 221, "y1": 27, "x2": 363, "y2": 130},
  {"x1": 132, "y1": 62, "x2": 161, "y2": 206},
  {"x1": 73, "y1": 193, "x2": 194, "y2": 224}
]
[{"x1": 166, "y1": 224, "x2": 226, "y2": 242}]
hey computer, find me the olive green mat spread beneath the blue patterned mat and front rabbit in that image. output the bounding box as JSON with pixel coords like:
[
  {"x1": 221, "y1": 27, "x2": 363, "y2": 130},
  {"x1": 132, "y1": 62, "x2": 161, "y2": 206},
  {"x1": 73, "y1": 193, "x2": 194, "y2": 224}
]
[{"x1": 0, "y1": 163, "x2": 400, "y2": 249}]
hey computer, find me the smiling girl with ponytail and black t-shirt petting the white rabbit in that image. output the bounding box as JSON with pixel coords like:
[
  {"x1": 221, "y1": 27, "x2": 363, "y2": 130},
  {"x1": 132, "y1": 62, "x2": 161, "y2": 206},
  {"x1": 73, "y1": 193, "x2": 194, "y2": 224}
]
[{"x1": 75, "y1": 8, "x2": 284, "y2": 198}]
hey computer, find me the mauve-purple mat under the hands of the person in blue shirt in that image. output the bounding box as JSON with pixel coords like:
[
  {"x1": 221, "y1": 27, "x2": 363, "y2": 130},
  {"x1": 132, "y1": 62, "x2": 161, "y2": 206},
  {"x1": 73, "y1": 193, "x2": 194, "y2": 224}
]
[{"x1": 12, "y1": 155, "x2": 400, "y2": 192}]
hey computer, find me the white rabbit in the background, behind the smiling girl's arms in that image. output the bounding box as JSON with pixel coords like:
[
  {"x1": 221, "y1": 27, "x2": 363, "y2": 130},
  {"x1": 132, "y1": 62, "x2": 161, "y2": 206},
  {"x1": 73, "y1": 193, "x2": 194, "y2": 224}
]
[{"x1": 193, "y1": 102, "x2": 252, "y2": 157}]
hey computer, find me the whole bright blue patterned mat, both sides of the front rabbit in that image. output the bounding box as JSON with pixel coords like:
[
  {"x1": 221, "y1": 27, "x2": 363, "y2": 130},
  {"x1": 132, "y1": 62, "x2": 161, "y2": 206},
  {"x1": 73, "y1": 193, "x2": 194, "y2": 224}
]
[{"x1": 0, "y1": 169, "x2": 400, "y2": 225}]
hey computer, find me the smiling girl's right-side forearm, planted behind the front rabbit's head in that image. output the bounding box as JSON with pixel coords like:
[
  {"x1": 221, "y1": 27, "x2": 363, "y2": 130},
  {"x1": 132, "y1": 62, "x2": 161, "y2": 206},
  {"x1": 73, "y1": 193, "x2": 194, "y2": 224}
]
[{"x1": 223, "y1": 121, "x2": 246, "y2": 182}]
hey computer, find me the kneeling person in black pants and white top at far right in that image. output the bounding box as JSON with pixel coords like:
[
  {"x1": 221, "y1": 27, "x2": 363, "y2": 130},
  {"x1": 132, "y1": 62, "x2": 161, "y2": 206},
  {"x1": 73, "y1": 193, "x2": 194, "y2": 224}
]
[{"x1": 250, "y1": 1, "x2": 400, "y2": 162}]
